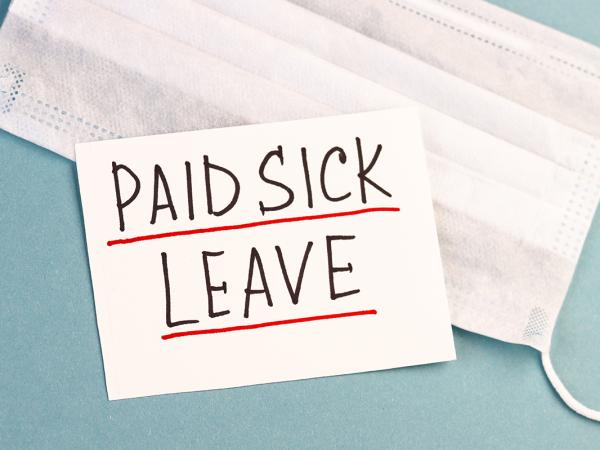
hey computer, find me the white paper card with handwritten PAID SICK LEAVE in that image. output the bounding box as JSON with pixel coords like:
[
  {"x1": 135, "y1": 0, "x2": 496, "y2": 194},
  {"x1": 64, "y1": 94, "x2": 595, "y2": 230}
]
[{"x1": 76, "y1": 109, "x2": 455, "y2": 399}]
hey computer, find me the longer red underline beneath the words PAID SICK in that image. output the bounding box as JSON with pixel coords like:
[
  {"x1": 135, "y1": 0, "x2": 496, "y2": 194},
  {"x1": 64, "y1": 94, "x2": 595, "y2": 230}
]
[{"x1": 106, "y1": 208, "x2": 400, "y2": 247}]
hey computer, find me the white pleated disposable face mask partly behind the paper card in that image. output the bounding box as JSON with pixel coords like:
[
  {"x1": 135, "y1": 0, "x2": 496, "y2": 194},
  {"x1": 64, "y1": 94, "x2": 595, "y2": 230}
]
[{"x1": 0, "y1": 0, "x2": 600, "y2": 420}]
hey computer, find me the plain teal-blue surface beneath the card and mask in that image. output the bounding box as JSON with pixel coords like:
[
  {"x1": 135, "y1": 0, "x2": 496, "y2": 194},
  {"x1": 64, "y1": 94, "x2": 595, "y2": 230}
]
[{"x1": 0, "y1": 0, "x2": 600, "y2": 449}]
